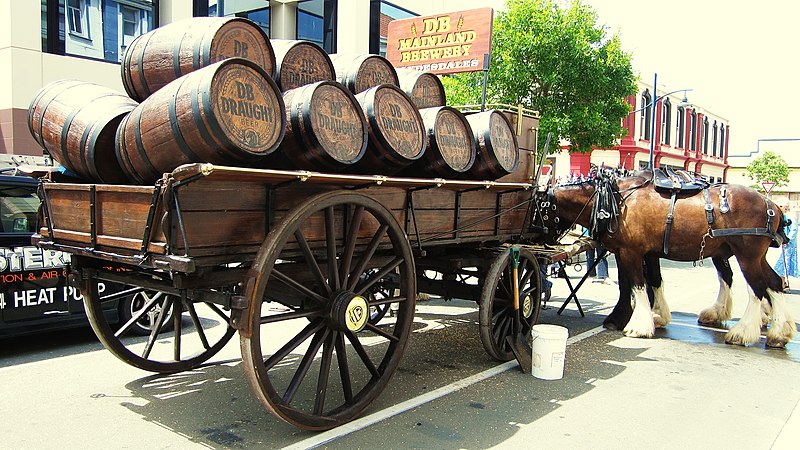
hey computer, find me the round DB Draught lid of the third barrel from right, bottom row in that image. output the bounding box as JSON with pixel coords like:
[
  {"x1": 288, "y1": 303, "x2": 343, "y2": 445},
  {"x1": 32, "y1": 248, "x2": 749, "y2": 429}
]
[{"x1": 367, "y1": 84, "x2": 425, "y2": 160}]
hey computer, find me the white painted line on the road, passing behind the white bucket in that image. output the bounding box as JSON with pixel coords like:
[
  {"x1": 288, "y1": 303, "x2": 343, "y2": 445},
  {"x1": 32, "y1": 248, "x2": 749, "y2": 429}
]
[{"x1": 284, "y1": 326, "x2": 605, "y2": 450}]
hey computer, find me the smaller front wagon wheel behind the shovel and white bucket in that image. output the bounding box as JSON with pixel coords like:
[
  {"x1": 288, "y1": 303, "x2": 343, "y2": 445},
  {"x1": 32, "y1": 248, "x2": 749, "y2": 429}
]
[{"x1": 478, "y1": 248, "x2": 542, "y2": 361}]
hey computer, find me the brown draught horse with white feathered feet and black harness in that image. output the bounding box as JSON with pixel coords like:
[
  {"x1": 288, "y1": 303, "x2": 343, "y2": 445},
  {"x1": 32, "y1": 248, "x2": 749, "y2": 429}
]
[{"x1": 542, "y1": 170, "x2": 796, "y2": 347}]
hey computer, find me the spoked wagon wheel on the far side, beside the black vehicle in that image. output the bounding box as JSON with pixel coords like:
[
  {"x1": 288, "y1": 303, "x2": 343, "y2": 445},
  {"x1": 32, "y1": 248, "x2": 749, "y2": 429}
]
[{"x1": 81, "y1": 278, "x2": 236, "y2": 373}]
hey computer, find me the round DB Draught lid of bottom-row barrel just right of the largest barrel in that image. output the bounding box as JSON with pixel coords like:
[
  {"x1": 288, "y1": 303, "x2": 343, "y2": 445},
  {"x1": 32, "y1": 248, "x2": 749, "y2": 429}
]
[{"x1": 309, "y1": 82, "x2": 367, "y2": 164}]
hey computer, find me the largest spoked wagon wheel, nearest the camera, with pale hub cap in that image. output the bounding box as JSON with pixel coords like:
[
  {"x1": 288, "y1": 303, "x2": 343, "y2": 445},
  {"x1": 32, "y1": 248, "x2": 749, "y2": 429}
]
[{"x1": 240, "y1": 191, "x2": 416, "y2": 430}]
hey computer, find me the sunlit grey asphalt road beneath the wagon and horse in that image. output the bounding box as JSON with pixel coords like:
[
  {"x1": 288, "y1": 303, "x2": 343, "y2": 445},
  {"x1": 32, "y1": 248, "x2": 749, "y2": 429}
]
[{"x1": 0, "y1": 251, "x2": 800, "y2": 449}]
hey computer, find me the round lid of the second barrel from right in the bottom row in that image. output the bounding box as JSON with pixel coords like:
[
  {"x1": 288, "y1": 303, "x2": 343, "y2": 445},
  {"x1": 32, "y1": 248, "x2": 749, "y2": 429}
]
[{"x1": 432, "y1": 107, "x2": 475, "y2": 172}]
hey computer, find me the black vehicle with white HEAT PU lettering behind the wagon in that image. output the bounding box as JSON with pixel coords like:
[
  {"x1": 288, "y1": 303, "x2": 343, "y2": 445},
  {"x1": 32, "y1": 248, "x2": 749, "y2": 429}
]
[{"x1": 0, "y1": 168, "x2": 169, "y2": 338}]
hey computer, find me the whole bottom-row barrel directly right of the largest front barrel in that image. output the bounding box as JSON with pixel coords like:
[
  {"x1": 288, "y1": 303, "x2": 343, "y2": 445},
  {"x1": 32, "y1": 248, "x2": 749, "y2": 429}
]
[{"x1": 266, "y1": 81, "x2": 368, "y2": 171}]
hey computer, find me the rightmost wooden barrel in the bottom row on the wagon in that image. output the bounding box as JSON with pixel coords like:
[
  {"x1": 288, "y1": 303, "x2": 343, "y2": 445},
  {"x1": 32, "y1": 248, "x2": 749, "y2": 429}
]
[{"x1": 467, "y1": 110, "x2": 519, "y2": 180}]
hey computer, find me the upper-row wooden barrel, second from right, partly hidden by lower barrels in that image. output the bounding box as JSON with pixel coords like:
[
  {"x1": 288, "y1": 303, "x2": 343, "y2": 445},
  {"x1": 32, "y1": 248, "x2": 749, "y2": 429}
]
[{"x1": 330, "y1": 53, "x2": 399, "y2": 94}]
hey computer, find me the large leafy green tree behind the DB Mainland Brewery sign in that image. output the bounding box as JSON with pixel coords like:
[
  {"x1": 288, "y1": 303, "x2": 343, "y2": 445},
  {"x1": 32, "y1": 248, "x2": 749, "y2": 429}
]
[{"x1": 443, "y1": 0, "x2": 636, "y2": 152}]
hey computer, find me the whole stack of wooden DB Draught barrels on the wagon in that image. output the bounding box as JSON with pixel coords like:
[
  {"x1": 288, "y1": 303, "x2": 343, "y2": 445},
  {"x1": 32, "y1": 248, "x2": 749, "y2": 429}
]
[{"x1": 28, "y1": 17, "x2": 519, "y2": 184}]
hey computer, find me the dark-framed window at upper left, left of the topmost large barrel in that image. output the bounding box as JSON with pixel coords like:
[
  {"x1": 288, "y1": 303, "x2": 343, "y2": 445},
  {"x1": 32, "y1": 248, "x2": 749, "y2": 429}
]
[{"x1": 41, "y1": 0, "x2": 158, "y2": 62}]
